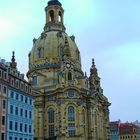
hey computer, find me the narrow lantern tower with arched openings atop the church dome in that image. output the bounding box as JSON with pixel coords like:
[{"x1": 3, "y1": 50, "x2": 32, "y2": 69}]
[{"x1": 44, "y1": 0, "x2": 65, "y2": 32}]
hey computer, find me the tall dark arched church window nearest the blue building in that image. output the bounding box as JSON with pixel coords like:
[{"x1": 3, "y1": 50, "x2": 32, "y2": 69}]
[{"x1": 48, "y1": 108, "x2": 55, "y2": 138}]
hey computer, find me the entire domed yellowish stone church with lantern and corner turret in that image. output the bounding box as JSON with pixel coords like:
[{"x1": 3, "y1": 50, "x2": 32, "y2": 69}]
[{"x1": 27, "y1": 0, "x2": 110, "y2": 140}]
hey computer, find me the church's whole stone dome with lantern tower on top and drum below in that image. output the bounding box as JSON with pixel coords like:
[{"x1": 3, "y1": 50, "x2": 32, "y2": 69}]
[{"x1": 27, "y1": 0, "x2": 84, "y2": 89}]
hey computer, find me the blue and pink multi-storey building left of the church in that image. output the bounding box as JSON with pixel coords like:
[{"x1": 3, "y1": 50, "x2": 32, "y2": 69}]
[{"x1": 0, "y1": 52, "x2": 34, "y2": 140}]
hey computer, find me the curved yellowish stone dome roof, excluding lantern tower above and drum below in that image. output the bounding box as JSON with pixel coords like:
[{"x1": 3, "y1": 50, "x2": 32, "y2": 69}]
[{"x1": 29, "y1": 31, "x2": 81, "y2": 71}]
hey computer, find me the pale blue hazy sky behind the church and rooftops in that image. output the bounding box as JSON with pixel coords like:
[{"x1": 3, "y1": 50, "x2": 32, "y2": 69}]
[{"x1": 0, "y1": 0, "x2": 140, "y2": 121}]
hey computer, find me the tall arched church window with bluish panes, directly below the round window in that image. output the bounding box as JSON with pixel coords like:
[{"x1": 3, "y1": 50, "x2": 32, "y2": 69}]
[{"x1": 68, "y1": 106, "x2": 75, "y2": 137}]
